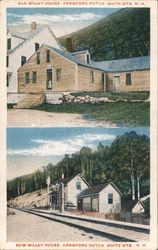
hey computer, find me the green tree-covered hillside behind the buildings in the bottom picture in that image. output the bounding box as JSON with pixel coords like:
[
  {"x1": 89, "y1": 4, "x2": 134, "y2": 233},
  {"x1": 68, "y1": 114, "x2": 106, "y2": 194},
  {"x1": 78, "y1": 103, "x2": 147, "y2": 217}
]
[{"x1": 7, "y1": 131, "x2": 150, "y2": 200}]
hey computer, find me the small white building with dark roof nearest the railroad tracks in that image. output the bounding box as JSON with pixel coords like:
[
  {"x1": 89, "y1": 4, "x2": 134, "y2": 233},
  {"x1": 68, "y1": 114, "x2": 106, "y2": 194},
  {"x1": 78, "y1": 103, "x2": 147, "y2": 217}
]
[{"x1": 78, "y1": 182, "x2": 122, "y2": 214}]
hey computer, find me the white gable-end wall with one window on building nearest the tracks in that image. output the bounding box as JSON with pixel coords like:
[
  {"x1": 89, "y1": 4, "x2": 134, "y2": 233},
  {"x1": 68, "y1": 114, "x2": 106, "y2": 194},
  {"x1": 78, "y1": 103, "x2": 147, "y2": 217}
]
[{"x1": 99, "y1": 184, "x2": 121, "y2": 214}]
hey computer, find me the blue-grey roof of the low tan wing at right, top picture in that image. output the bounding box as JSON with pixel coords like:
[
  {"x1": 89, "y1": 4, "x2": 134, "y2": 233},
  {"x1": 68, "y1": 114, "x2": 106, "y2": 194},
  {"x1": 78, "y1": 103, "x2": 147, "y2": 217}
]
[{"x1": 92, "y1": 56, "x2": 150, "y2": 72}]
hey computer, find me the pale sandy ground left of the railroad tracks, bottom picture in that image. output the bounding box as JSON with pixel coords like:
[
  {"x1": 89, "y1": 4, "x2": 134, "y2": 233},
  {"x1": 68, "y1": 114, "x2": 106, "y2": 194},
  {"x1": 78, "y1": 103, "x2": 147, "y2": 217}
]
[{"x1": 7, "y1": 209, "x2": 109, "y2": 242}]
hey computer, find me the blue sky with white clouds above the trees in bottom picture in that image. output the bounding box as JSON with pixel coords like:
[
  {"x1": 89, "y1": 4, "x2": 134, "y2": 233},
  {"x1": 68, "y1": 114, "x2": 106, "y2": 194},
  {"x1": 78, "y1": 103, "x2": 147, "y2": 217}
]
[{"x1": 7, "y1": 128, "x2": 149, "y2": 179}]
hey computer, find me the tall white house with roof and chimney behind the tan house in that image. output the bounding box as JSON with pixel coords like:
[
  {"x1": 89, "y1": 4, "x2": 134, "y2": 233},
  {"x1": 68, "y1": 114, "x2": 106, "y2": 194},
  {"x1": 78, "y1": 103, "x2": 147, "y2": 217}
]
[{"x1": 6, "y1": 22, "x2": 63, "y2": 98}]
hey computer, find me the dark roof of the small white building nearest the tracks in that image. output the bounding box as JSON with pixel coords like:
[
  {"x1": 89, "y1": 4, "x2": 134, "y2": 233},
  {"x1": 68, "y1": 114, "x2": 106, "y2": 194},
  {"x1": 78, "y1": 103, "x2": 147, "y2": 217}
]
[{"x1": 78, "y1": 182, "x2": 122, "y2": 197}]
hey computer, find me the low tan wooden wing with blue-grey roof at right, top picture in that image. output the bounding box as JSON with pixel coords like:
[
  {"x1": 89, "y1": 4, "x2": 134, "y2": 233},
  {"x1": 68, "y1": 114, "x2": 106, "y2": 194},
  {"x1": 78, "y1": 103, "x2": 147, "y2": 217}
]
[{"x1": 93, "y1": 56, "x2": 150, "y2": 92}]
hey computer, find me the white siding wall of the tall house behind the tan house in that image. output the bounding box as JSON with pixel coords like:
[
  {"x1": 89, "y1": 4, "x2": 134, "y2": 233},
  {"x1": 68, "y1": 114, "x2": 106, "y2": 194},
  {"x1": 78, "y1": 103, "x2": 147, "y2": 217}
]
[{"x1": 7, "y1": 27, "x2": 60, "y2": 93}]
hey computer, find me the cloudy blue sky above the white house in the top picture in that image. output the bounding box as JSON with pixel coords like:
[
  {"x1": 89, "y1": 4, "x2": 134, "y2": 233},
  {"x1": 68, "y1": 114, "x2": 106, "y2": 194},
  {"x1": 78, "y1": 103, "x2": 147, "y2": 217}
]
[{"x1": 7, "y1": 8, "x2": 118, "y2": 37}]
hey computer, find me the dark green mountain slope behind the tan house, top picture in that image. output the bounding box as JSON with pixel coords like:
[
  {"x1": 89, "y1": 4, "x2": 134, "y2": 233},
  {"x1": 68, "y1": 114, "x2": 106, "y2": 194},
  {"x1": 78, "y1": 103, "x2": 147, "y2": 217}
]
[{"x1": 59, "y1": 8, "x2": 150, "y2": 61}]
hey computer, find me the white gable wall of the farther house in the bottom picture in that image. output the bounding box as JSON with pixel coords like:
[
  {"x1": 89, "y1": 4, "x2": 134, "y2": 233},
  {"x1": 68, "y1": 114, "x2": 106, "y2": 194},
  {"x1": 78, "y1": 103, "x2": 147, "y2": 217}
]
[{"x1": 66, "y1": 176, "x2": 88, "y2": 206}]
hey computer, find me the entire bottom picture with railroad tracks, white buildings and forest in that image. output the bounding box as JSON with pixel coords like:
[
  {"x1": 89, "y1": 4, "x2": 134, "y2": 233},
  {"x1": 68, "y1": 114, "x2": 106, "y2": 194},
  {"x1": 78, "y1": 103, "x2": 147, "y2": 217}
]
[{"x1": 7, "y1": 127, "x2": 150, "y2": 243}]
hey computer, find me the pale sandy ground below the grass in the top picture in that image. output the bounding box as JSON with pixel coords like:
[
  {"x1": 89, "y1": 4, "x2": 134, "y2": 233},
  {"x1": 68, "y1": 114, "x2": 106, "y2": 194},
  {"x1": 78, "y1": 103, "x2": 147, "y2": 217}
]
[{"x1": 7, "y1": 109, "x2": 115, "y2": 127}]
